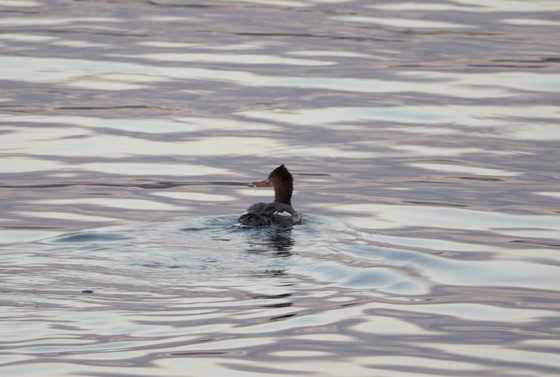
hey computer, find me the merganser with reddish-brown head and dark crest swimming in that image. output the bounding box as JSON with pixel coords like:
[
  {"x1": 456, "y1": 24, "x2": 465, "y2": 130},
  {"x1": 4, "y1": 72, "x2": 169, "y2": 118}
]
[{"x1": 237, "y1": 164, "x2": 301, "y2": 226}]
